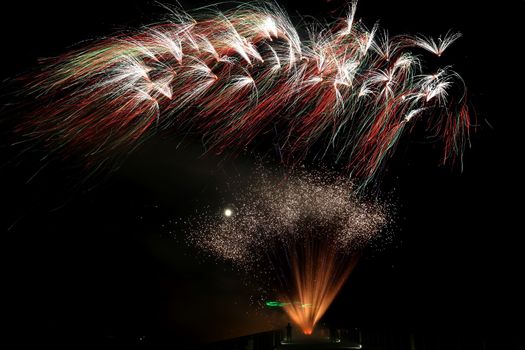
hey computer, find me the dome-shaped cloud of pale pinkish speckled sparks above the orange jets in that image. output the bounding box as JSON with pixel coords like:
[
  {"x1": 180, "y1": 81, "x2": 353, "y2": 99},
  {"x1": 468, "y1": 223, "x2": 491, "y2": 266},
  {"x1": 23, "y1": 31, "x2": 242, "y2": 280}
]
[{"x1": 191, "y1": 172, "x2": 386, "y2": 265}]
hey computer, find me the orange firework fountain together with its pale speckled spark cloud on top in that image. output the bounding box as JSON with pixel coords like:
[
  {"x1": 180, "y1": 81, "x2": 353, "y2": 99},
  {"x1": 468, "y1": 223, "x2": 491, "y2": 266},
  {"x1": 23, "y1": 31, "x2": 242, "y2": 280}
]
[{"x1": 189, "y1": 168, "x2": 389, "y2": 334}]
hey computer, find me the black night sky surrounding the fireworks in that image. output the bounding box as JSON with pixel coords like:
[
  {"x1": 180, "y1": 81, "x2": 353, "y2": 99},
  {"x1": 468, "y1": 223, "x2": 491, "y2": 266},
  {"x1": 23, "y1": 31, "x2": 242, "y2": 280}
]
[{"x1": 0, "y1": 0, "x2": 525, "y2": 348}]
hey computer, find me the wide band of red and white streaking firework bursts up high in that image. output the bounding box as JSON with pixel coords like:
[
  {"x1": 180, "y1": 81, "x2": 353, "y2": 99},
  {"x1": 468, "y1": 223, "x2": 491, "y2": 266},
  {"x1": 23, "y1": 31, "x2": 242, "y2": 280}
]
[{"x1": 14, "y1": 2, "x2": 470, "y2": 183}]
